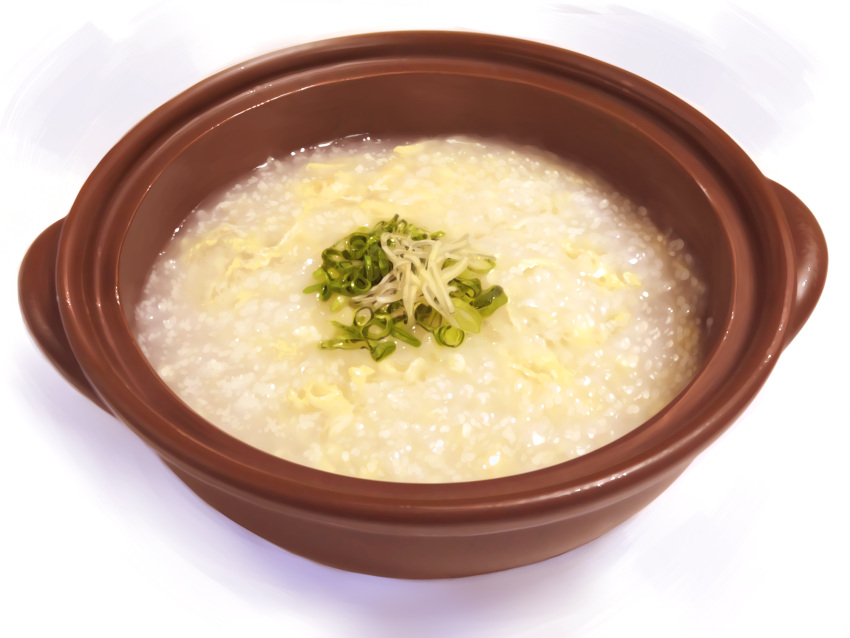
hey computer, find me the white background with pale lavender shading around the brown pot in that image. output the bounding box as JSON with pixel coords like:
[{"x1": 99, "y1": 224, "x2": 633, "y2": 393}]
[{"x1": 0, "y1": 0, "x2": 850, "y2": 637}]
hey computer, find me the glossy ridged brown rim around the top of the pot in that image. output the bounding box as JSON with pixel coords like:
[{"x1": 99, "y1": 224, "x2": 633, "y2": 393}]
[{"x1": 57, "y1": 31, "x2": 795, "y2": 529}]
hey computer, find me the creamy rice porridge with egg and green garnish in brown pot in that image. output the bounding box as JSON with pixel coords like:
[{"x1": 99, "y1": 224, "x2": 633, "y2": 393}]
[{"x1": 135, "y1": 137, "x2": 706, "y2": 483}]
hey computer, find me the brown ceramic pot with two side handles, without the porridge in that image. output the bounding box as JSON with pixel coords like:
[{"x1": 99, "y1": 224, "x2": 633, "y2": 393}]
[{"x1": 20, "y1": 32, "x2": 827, "y2": 578}]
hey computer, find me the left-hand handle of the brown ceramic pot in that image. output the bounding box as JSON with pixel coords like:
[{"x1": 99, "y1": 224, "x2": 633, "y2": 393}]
[{"x1": 18, "y1": 219, "x2": 109, "y2": 412}]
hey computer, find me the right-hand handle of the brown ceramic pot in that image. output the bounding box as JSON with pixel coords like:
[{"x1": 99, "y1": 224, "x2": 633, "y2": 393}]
[{"x1": 770, "y1": 180, "x2": 829, "y2": 347}]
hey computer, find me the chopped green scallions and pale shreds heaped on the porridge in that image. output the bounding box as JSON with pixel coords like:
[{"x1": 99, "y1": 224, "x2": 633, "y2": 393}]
[{"x1": 304, "y1": 215, "x2": 508, "y2": 361}]
